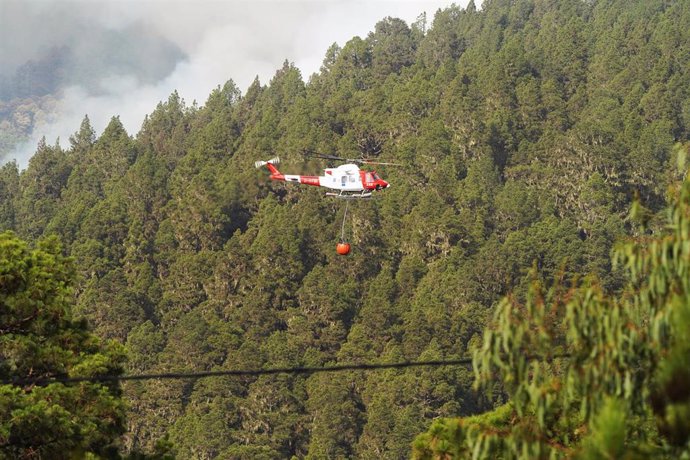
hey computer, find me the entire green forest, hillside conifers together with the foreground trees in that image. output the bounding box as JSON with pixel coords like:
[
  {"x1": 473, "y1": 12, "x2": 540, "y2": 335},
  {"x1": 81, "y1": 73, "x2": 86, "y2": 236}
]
[{"x1": 0, "y1": 0, "x2": 690, "y2": 459}]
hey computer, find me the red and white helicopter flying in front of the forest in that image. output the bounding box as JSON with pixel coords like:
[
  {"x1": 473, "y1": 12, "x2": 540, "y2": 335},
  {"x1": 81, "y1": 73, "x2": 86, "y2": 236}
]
[{"x1": 254, "y1": 152, "x2": 399, "y2": 199}]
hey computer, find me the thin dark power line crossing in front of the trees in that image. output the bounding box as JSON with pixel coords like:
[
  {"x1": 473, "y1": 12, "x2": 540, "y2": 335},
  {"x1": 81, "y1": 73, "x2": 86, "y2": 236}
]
[{"x1": 1, "y1": 353, "x2": 570, "y2": 386}]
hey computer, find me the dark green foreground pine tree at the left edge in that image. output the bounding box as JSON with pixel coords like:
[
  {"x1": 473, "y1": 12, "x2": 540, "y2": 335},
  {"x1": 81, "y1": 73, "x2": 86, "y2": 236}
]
[{"x1": 0, "y1": 232, "x2": 124, "y2": 459}]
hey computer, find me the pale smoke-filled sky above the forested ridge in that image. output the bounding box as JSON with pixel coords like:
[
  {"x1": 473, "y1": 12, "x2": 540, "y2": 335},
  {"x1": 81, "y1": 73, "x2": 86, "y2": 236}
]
[{"x1": 0, "y1": 0, "x2": 468, "y2": 164}]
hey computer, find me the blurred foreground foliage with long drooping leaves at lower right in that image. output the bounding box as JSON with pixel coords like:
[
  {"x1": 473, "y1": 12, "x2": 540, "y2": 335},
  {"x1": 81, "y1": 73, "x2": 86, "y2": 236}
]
[{"x1": 414, "y1": 144, "x2": 690, "y2": 459}]
